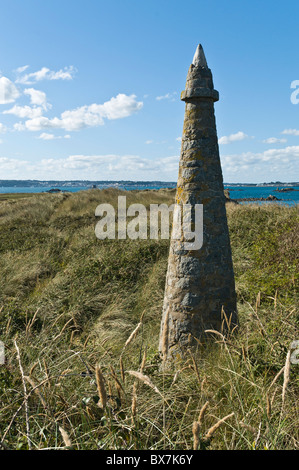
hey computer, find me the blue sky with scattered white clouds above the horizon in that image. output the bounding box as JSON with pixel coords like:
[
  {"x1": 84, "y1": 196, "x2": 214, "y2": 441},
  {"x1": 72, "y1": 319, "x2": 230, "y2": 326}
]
[{"x1": 0, "y1": 0, "x2": 299, "y2": 183}]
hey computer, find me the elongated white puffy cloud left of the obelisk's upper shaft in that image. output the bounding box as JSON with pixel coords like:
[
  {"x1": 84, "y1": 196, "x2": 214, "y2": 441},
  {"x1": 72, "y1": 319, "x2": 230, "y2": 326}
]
[{"x1": 25, "y1": 94, "x2": 143, "y2": 131}]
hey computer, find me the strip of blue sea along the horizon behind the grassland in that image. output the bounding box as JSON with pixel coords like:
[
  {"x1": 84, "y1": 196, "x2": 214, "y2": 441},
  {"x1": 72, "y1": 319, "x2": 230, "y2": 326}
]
[{"x1": 0, "y1": 181, "x2": 299, "y2": 206}]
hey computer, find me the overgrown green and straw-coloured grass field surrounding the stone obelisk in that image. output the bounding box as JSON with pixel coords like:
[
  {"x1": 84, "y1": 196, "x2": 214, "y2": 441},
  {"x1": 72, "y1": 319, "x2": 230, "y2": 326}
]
[{"x1": 0, "y1": 189, "x2": 299, "y2": 450}]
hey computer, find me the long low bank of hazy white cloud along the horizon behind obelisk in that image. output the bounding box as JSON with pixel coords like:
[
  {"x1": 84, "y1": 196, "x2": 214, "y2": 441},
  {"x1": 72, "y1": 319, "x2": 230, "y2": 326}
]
[{"x1": 0, "y1": 146, "x2": 299, "y2": 182}]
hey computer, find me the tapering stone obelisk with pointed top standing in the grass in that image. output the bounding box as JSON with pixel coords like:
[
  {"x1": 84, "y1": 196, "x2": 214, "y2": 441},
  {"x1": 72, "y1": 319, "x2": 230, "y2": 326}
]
[{"x1": 159, "y1": 45, "x2": 237, "y2": 358}]
